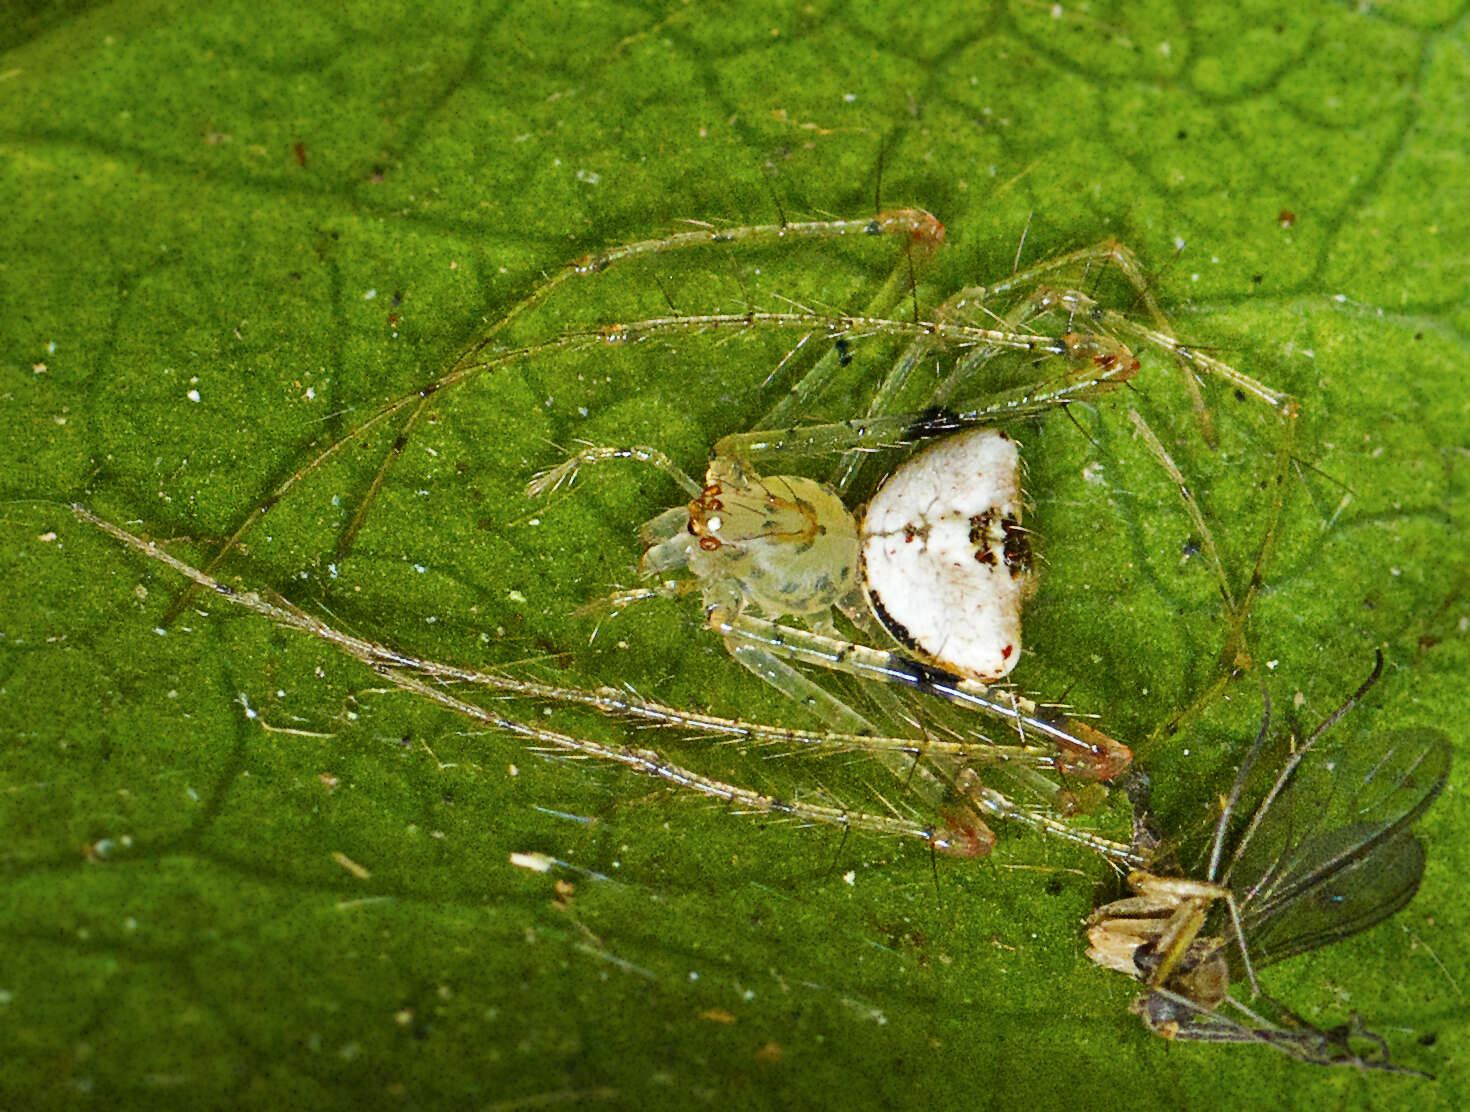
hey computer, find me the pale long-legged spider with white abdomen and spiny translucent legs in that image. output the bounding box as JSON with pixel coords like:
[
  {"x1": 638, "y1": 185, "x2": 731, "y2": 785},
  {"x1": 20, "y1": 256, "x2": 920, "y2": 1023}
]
[{"x1": 138, "y1": 209, "x2": 1295, "y2": 853}]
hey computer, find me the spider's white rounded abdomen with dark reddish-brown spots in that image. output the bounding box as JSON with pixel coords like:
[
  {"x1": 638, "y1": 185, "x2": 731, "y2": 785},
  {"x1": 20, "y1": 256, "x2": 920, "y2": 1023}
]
[{"x1": 860, "y1": 428, "x2": 1030, "y2": 682}]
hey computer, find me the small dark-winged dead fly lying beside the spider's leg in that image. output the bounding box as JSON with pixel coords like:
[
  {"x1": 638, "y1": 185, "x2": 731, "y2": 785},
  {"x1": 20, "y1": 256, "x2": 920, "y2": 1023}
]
[{"x1": 1088, "y1": 653, "x2": 1451, "y2": 1072}]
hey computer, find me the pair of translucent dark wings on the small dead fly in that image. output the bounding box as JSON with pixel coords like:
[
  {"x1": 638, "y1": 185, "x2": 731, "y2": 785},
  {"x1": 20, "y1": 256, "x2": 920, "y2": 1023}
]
[{"x1": 1227, "y1": 730, "x2": 1449, "y2": 965}]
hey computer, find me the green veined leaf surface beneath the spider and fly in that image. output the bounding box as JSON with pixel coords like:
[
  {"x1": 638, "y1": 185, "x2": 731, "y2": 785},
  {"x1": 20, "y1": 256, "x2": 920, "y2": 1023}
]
[{"x1": 0, "y1": 0, "x2": 1470, "y2": 1108}]
